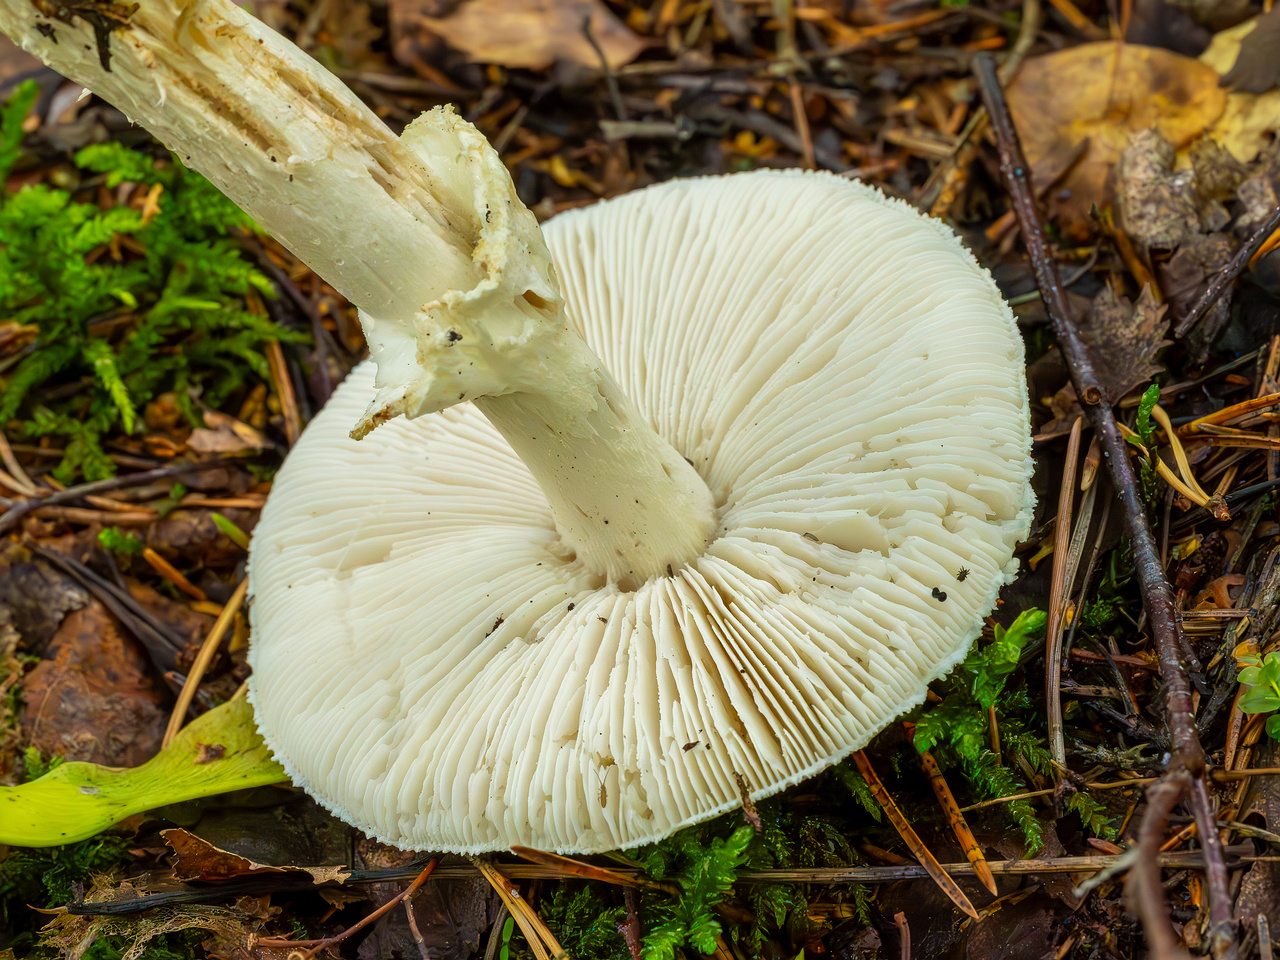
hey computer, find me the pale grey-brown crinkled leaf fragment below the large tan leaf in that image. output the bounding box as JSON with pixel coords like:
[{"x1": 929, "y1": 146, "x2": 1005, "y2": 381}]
[{"x1": 1116, "y1": 129, "x2": 1199, "y2": 251}]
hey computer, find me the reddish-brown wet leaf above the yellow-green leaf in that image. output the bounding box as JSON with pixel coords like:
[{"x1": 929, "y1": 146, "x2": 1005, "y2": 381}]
[{"x1": 19, "y1": 600, "x2": 168, "y2": 773}]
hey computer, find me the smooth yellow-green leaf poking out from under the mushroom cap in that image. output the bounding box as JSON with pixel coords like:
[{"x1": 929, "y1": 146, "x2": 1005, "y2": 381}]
[{"x1": 0, "y1": 686, "x2": 287, "y2": 846}]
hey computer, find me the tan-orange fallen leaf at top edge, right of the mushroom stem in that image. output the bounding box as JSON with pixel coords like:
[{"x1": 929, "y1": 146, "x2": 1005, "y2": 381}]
[{"x1": 393, "y1": 0, "x2": 645, "y2": 70}]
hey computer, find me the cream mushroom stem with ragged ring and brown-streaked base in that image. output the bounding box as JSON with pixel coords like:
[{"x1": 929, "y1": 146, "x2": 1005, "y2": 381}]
[{"x1": 0, "y1": 0, "x2": 716, "y2": 585}]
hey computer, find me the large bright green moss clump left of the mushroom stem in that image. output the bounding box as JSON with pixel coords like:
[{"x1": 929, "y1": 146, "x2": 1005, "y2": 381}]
[{"x1": 0, "y1": 84, "x2": 302, "y2": 483}]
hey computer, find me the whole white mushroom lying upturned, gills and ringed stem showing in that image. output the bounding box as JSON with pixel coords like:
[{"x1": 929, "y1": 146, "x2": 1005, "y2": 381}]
[{"x1": 0, "y1": 0, "x2": 1032, "y2": 851}]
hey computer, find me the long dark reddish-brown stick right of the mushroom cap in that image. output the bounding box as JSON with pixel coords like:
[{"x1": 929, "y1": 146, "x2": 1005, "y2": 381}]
[{"x1": 974, "y1": 54, "x2": 1236, "y2": 960}]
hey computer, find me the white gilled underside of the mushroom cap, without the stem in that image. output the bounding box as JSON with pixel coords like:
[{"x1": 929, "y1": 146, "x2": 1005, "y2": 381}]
[{"x1": 250, "y1": 172, "x2": 1033, "y2": 854}]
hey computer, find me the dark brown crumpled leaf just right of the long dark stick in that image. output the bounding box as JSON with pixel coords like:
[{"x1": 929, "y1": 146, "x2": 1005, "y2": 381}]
[{"x1": 1080, "y1": 287, "x2": 1169, "y2": 401}]
